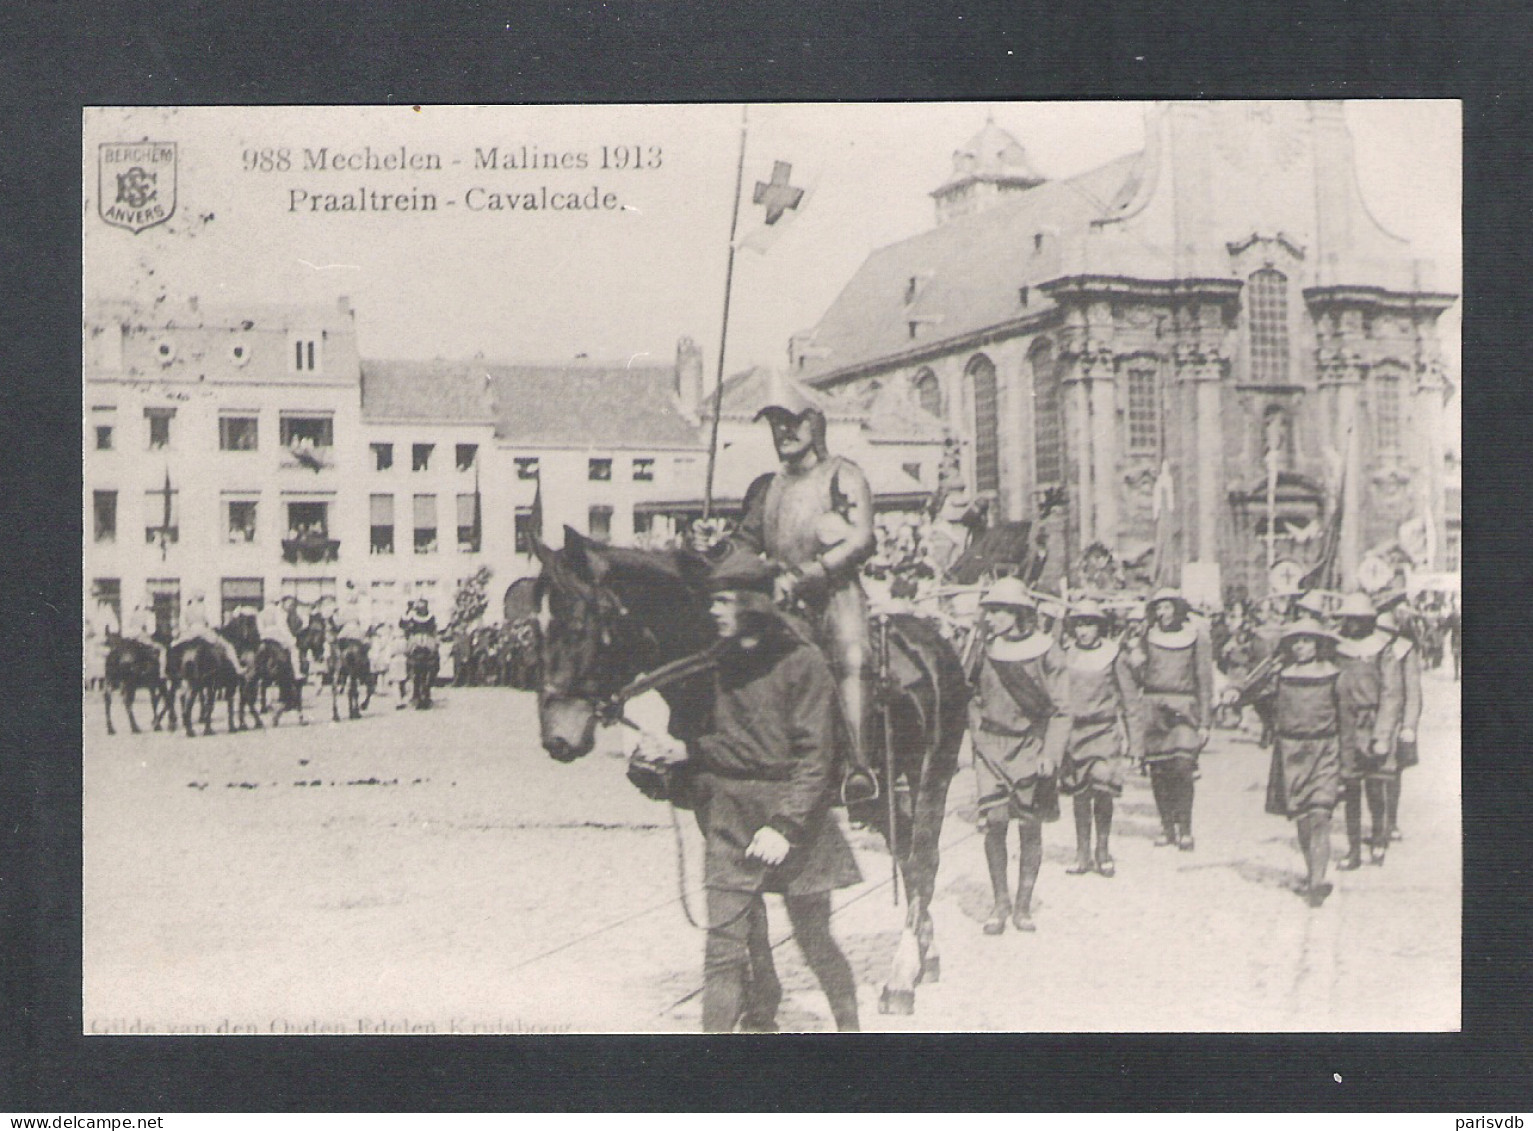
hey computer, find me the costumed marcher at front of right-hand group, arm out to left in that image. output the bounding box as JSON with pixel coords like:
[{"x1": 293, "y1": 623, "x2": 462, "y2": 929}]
[{"x1": 1228, "y1": 618, "x2": 1341, "y2": 907}]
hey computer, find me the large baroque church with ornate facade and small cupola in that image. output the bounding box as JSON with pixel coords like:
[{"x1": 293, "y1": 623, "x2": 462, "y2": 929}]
[{"x1": 789, "y1": 101, "x2": 1456, "y2": 596}]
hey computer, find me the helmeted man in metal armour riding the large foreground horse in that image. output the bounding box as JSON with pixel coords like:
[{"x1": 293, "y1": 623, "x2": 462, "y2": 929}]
[{"x1": 739, "y1": 370, "x2": 877, "y2": 803}]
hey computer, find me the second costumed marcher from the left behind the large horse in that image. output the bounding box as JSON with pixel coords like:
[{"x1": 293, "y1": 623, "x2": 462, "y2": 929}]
[{"x1": 1059, "y1": 601, "x2": 1139, "y2": 877}]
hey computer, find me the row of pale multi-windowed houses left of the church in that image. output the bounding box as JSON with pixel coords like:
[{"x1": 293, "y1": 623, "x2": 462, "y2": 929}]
[{"x1": 83, "y1": 299, "x2": 944, "y2": 631}]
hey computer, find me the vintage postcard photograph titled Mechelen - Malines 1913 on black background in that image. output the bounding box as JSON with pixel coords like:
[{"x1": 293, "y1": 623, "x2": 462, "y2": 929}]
[{"x1": 81, "y1": 100, "x2": 1462, "y2": 1029}]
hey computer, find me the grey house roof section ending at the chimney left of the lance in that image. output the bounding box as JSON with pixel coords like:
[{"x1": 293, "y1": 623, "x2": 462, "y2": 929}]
[{"x1": 483, "y1": 362, "x2": 705, "y2": 447}]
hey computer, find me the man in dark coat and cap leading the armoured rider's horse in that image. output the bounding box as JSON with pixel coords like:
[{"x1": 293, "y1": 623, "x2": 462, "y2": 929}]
[{"x1": 681, "y1": 550, "x2": 862, "y2": 1033}]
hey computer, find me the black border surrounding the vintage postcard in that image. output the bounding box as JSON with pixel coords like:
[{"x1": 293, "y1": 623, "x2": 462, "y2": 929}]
[{"x1": 0, "y1": 0, "x2": 1533, "y2": 1114}]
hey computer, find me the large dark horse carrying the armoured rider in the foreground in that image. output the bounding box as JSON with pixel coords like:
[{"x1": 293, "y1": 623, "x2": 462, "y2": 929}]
[{"x1": 537, "y1": 527, "x2": 967, "y2": 1013}]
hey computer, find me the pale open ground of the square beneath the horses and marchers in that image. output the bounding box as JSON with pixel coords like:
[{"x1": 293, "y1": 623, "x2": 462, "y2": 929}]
[{"x1": 83, "y1": 673, "x2": 1461, "y2": 1034}]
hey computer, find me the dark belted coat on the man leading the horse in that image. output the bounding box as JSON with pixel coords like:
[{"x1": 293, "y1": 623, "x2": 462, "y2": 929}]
[{"x1": 687, "y1": 622, "x2": 862, "y2": 895}]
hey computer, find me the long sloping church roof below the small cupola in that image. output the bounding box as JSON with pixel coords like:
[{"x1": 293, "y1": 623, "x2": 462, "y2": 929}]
[{"x1": 797, "y1": 153, "x2": 1142, "y2": 382}]
